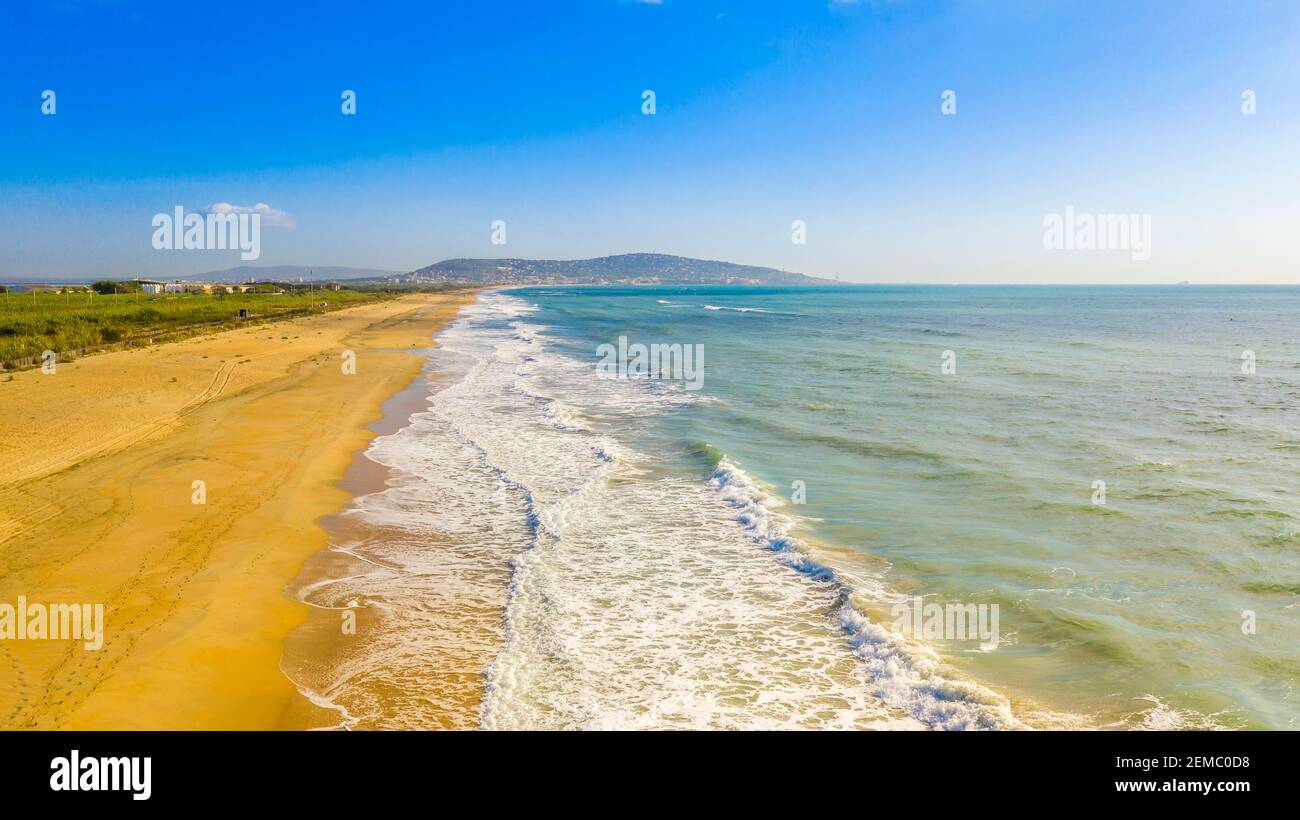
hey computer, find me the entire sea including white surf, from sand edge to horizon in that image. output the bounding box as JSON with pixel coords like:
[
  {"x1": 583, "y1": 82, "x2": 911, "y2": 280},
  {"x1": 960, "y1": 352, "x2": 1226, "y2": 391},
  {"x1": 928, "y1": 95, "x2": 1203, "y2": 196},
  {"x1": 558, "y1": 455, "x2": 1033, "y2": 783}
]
[{"x1": 287, "y1": 286, "x2": 1300, "y2": 730}]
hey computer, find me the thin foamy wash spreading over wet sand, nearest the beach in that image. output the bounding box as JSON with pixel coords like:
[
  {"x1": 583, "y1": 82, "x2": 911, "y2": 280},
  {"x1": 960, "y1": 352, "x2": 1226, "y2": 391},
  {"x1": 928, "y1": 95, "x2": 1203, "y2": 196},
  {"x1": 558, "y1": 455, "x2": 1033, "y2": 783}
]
[{"x1": 286, "y1": 296, "x2": 543, "y2": 729}]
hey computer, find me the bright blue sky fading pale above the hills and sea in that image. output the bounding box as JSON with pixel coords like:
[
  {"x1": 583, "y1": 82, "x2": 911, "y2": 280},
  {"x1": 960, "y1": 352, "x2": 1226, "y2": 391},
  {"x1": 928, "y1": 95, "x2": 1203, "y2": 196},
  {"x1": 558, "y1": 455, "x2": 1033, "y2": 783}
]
[{"x1": 0, "y1": 0, "x2": 1300, "y2": 283}]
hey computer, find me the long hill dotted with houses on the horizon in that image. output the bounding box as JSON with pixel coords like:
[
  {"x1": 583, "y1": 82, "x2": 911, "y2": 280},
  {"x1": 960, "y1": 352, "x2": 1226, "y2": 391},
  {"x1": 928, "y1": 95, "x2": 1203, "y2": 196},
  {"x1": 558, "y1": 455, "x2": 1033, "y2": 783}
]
[{"x1": 386, "y1": 253, "x2": 828, "y2": 285}]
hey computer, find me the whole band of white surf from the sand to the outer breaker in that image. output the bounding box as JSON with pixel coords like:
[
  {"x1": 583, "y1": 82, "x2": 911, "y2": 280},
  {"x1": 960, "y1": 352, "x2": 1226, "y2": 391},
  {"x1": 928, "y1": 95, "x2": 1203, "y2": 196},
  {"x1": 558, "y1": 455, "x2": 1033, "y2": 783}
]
[{"x1": 299, "y1": 294, "x2": 1019, "y2": 729}]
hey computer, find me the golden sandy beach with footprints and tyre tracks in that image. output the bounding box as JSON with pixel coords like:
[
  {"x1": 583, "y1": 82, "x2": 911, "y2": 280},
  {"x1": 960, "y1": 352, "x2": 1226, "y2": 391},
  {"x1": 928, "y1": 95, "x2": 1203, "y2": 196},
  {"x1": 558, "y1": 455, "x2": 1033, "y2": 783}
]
[{"x1": 0, "y1": 291, "x2": 475, "y2": 729}]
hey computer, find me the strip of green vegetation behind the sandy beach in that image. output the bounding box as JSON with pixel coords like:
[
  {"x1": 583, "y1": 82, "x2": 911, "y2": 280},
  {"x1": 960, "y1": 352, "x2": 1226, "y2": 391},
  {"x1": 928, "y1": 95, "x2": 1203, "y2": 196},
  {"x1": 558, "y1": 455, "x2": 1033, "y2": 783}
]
[{"x1": 0, "y1": 282, "x2": 397, "y2": 369}]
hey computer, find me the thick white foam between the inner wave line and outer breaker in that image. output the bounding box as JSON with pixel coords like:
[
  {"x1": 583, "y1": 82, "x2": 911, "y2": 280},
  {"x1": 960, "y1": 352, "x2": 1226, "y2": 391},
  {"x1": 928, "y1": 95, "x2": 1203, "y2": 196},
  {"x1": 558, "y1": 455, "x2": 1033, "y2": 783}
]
[{"x1": 460, "y1": 294, "x2": 1045, "y2": 729}]
